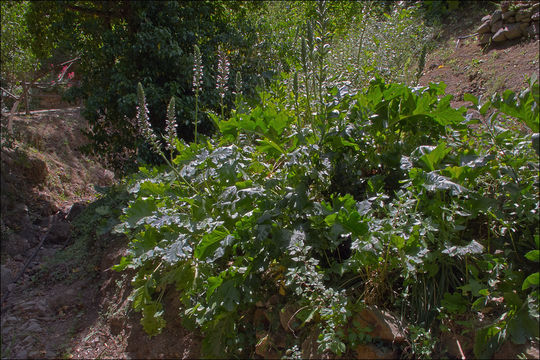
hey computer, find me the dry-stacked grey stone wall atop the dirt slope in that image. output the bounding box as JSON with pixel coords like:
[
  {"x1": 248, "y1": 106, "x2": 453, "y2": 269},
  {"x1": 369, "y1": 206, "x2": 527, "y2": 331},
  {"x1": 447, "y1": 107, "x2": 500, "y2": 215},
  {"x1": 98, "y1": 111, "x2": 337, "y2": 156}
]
[{"x1": 476, "y1": 1, "x2": 540, "y2": 45}]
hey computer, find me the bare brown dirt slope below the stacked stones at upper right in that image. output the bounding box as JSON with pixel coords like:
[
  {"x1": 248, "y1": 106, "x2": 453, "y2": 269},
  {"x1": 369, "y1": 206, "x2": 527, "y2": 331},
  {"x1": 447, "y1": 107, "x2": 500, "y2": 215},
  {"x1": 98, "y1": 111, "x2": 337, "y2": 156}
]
[{"x1": 419, "y1": 5, "x2": 540, "y2": 107}]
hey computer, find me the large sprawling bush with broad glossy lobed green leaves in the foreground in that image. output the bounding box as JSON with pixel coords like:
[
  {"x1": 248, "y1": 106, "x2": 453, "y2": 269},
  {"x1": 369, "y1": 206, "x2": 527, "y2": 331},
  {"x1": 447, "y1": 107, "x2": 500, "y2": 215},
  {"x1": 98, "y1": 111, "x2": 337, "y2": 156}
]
[{"x1": 112, "y1": 69, "x2": 539, "y2": 357}]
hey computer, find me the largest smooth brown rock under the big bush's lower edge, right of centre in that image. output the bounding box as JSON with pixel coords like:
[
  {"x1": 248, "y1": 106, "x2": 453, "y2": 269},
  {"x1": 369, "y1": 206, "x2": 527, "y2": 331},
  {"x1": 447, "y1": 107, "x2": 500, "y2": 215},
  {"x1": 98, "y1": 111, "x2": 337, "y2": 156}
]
[{"x1": 354, "y1": 306, "x2": 406, "y2": 342}]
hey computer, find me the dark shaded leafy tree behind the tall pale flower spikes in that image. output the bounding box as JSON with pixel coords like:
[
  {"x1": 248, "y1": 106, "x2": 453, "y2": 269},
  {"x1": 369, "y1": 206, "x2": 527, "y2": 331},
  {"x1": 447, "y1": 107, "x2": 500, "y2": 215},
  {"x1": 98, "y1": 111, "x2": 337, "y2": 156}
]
[{"x1": 27, "y1": 1, "x2": 266, "y2": 172}]
